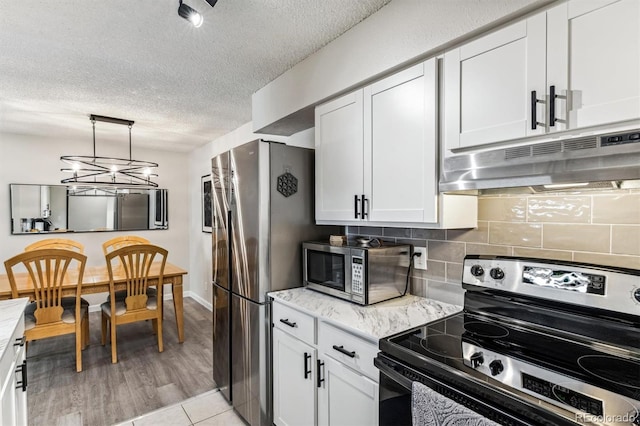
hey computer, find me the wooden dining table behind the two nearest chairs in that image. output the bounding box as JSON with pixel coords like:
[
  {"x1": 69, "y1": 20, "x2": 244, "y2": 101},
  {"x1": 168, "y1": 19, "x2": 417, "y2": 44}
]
[{"x1": 0, "y1": 262, "x2": 187, "y2": 343}]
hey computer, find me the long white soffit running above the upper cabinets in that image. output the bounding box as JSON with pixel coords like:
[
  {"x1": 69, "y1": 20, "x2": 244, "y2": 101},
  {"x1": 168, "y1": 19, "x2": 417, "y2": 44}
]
[{"x1": 252, "y1": 0, "x2": 549, "y2": 134}]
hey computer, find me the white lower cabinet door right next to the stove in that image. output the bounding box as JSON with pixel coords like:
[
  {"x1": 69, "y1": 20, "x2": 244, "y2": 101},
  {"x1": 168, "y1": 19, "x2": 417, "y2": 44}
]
[{"x1": 318, "y1": 357, "x2": 378, "y2": 426}]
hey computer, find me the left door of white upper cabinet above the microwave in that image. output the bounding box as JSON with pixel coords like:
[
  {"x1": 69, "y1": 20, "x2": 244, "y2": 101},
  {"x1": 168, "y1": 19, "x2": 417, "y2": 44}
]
[{"x1": 315, "y1": 90, "x2": 363, "y2": 220}]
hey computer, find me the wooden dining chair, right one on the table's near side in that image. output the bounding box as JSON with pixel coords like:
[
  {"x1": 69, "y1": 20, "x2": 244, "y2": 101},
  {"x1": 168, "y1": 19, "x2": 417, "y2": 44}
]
[{"x1": 101, "y1": 244, "x2": 168, "y2": 364}]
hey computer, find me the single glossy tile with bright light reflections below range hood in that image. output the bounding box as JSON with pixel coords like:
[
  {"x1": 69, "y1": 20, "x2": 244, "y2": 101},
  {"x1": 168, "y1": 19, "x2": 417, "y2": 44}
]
[{"x1": 527, "y1": 195, "x2": 591, "y2": 223}]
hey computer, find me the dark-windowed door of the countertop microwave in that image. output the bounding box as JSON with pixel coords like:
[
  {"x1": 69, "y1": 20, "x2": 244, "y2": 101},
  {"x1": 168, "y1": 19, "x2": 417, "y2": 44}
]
[{"x1": 303, "y1": 243, "x2": 351, "y2": 296}]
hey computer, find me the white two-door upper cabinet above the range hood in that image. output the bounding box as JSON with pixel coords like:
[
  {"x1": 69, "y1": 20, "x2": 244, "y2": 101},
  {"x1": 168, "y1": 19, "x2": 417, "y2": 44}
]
[{"x1": 444, "y1": 0, "x2": 640, "y2": 150}]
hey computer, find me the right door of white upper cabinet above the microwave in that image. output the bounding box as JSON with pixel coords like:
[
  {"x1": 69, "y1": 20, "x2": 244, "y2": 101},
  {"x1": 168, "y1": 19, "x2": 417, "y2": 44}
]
[{"x1": 364, "y1": 59, "x2": 438, "y2": 222}]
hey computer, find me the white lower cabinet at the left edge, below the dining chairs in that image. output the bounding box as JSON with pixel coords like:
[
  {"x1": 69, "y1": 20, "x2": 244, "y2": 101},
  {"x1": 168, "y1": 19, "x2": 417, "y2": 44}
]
[{"x1": 0, "y1": 310, "x2": 27, "y2": 426}]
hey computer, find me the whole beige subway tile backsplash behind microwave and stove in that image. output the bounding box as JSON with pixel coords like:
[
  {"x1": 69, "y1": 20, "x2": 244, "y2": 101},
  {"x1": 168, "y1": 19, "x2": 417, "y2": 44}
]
[{"x1": 349, "y1": 190, "x2": 640, "y2": 304}]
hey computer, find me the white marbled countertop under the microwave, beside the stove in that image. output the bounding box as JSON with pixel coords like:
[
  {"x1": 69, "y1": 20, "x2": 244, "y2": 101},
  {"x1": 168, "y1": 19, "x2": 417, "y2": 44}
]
[{"x1": 269, "y1": 288, "x2": 462, "y2": 343}]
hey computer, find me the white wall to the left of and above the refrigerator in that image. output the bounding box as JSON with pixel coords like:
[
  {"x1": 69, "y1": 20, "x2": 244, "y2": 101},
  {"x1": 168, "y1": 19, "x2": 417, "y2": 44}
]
[{"x1": 189, "y1": 122, "x2": 314, "y2": 308}]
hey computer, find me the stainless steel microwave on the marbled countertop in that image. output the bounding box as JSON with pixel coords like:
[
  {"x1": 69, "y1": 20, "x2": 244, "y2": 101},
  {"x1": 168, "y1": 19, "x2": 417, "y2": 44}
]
[{"x1": 302, "y1": 241, "x2": 411, "y2": 305}]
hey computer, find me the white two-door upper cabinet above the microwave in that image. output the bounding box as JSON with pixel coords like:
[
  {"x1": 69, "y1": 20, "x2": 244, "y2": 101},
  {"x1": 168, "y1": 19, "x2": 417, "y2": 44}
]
[{"x1": 315, "y1": 58, "x2": 477, "y2": 228}]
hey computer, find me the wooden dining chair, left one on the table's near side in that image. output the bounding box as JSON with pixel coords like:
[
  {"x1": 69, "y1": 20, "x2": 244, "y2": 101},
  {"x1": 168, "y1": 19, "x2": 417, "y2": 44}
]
[{"x1": 4, "y1": 249, "x2": 88, "y2": 372}]
